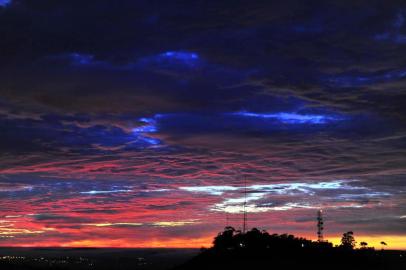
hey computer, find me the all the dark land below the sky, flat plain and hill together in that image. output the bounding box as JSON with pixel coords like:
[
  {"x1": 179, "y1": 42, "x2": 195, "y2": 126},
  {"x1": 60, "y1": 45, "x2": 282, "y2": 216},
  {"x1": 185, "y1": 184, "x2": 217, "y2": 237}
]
[{"x1": 0, "y1": 227, "x2": 406, "y2": 270}]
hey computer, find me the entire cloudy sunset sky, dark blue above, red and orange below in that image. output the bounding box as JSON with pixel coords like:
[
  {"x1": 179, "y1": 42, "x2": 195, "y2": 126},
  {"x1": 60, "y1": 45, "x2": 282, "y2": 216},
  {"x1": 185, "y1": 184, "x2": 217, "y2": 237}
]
[{"x1": 0, "y1": 0, "x2": 406, "y2": 249}]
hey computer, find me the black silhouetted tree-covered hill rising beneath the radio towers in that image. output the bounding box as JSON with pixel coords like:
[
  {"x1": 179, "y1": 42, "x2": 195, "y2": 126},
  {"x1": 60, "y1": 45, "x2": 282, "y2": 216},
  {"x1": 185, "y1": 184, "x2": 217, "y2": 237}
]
[{"x1": 177, "y1": 227, "x2": 406, "y2": 270}]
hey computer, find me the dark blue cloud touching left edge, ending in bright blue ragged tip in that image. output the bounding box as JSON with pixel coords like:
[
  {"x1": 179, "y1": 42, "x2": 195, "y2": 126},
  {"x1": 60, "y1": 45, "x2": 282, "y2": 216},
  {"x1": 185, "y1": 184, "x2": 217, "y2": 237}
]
[{"x1": 0, "y1": 112, "x2": 160, "y2": 154}]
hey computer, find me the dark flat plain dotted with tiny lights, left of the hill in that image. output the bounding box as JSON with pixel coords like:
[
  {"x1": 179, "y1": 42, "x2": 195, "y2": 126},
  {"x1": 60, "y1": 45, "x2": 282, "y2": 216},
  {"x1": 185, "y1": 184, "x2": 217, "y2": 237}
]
[{"x1": 0, "y1": 248, "x2": 199, "y2": 270}]
